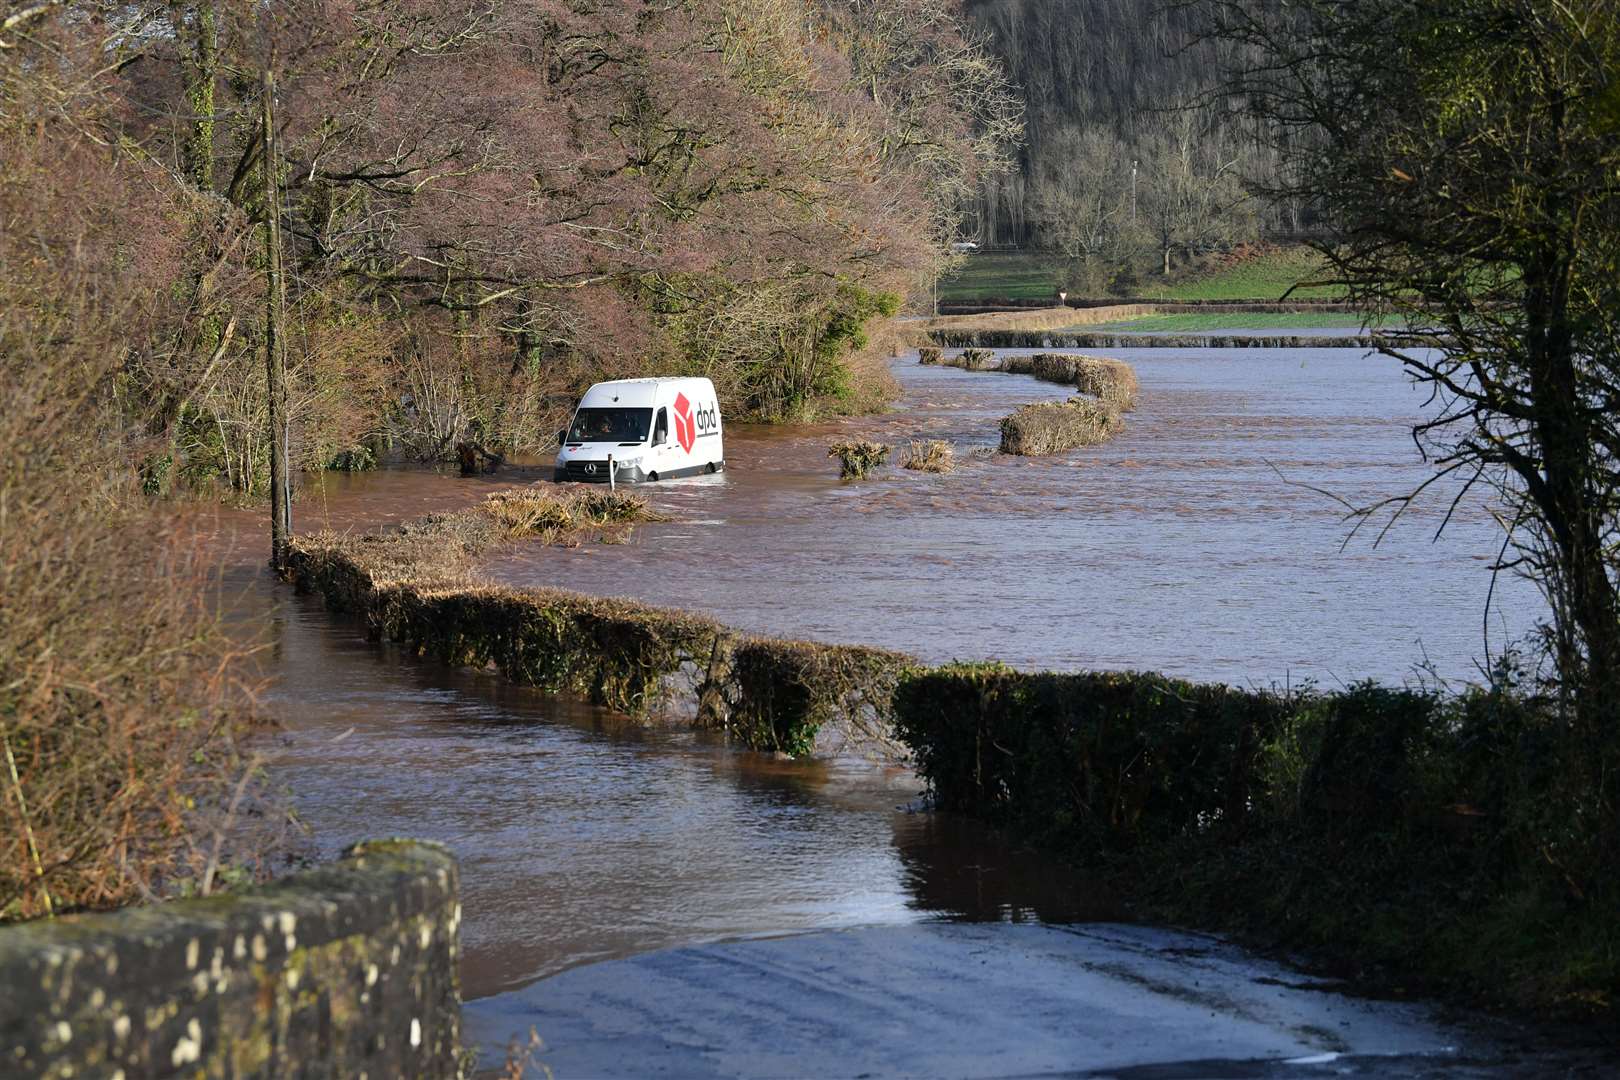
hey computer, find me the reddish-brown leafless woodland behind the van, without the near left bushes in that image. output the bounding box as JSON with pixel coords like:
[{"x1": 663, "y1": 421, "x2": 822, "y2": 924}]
[{"x1": 0, "y1": 0, "x2": 1017, "y2": 494}]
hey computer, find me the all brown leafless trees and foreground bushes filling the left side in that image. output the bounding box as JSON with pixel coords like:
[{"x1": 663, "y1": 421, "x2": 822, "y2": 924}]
[{"x1": 0, "y1": 0, "x2": 1019, "y2": 921}]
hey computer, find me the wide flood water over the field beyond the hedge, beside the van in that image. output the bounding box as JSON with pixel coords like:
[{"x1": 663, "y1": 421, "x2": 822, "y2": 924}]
[{"x1": 488, "y1": 348, "x2": 1542, "y2": 687}]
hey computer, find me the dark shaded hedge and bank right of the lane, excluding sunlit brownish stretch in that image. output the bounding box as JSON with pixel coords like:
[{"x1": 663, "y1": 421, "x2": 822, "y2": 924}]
[{"x1": 894, "y1": 664, "x2": 1620, "y2": 1015}]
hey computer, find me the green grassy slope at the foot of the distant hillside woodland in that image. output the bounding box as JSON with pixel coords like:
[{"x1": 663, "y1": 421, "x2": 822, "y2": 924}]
[{"x1": 940, "y1": 248, "x2": 1343, "y2": 302}]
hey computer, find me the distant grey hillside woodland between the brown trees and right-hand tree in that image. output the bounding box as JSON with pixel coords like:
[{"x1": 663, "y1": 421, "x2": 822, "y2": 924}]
[{"x1": 967, "y1": 0, "x2": 1307, "y2": 283}]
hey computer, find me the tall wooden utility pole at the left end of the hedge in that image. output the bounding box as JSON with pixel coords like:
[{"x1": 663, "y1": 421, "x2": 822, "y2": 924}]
[{"x1": 262, "y1": 58, "x2": 293, "y2": 572}]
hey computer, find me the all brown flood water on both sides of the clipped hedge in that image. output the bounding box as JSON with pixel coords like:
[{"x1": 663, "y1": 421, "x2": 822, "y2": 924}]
[{"x1": 222, "y1": 340, "x2": 1537, "y2": 1016}]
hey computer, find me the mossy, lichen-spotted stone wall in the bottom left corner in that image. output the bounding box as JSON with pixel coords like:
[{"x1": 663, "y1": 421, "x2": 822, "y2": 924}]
[{"x1": 0, "y1": 840, "x2": 462, "y2": 1080}]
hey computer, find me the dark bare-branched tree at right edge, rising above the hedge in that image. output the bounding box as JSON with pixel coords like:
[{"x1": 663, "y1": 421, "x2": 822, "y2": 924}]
[{"x1": 1205, "y1": 0, "x2": 1620, "y2": 860}]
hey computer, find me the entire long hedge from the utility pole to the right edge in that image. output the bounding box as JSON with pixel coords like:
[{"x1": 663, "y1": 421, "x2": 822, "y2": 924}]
[{"x1": 292, "y1": 521, "x2": 1620, "y2": 1014}]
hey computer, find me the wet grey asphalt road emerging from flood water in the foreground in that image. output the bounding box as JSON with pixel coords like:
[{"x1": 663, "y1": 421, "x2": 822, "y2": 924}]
[{"x1": 465, "y1": 923, "x2": 1612, "y2": 1080}]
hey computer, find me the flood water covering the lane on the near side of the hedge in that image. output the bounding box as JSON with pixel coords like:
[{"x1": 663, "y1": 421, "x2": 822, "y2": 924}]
[{"x1": 252, "y1": 569, "x2": 1101, "y2": 996}]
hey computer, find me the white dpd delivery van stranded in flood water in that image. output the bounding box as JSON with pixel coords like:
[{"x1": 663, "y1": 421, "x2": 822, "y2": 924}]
[{"x1": 552, "y1": 379, "x2": 726, "y2": 484}]
